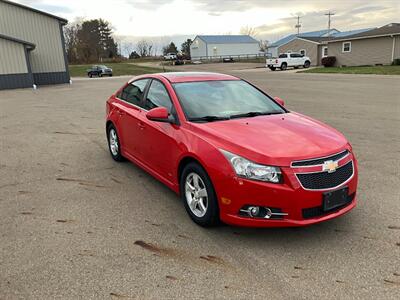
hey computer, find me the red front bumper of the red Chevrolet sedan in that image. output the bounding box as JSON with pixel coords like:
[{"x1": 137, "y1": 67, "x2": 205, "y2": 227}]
[{"x1": 215, "y1": 155, "x2": 358, "y2": 227}]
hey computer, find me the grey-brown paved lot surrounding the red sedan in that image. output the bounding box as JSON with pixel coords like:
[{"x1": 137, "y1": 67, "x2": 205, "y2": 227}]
[{"x1": 0, "y1": 64, "x2": 400, "y2": 299}]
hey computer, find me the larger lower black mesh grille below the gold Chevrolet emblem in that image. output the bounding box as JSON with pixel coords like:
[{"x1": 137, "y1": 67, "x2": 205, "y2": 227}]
[{"x1": 296, "y1": 161, "x2": 354, "y2": 190}]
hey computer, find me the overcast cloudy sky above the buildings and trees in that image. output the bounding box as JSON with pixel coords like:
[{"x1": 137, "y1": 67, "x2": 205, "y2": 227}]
[{"x1": 17, "y1": 0, "x2": 400, "y2": 46}]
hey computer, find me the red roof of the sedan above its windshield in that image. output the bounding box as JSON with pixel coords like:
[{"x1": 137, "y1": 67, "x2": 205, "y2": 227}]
[{"x1": 154, "y1": 72, "x2": 240, "y2": 83}]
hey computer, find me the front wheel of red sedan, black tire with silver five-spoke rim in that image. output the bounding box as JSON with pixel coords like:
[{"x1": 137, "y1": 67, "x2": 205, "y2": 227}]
[{"x1": 180, "y1": 163, "x2": 220, "y2": 227}]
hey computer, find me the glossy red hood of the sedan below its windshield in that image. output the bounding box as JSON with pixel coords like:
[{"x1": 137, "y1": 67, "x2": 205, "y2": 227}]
[{"x1": 192, "y1": 113, "x2": 348, "y2": 166}]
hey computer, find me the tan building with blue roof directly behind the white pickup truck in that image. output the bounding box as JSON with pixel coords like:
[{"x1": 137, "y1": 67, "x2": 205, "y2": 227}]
[{"x1": 267, "y1": 29, "x2": 370, "y2": 66}]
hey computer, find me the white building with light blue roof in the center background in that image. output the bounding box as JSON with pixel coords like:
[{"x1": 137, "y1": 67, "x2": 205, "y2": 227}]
[{"x1": 190, "y1": 35, "x2": 260, "y2": 60}]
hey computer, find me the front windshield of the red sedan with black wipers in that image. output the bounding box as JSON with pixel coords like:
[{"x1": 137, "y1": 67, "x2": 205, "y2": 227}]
[{"x1": 174, "y1": 80, "x2": 286, "y2": 122}]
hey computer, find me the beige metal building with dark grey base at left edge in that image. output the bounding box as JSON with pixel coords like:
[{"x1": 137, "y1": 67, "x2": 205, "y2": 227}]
[{"x1": 0, "y1": 0, "x2": 70, "y2": 90}]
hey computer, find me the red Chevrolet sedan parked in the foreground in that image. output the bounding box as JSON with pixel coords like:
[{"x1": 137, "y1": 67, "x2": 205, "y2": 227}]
[{"x1": 106, "y1": 73, "x2": 358, "y2": 227}]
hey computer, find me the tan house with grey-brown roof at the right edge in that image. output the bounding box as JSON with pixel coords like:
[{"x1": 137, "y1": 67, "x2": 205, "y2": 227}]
[{"x1": 326, "y1": 23, "x2": 400, "y2": 66}]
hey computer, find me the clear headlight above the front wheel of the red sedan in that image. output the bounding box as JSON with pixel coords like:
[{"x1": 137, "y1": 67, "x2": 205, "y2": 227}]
[{"x1": 220, "y1": 149, "x2": 282, "y2": 183}]
